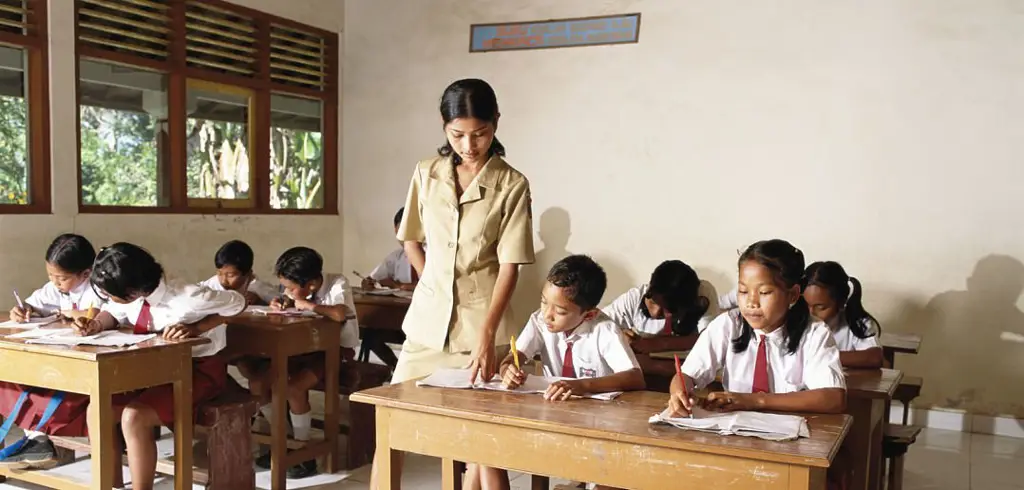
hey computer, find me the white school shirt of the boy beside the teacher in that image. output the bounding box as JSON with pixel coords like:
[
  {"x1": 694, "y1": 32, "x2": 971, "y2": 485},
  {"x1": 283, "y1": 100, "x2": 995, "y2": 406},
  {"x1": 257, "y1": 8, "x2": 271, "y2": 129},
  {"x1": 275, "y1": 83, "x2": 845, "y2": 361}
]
[{"x1": 515, "y1": 310, "x2": 640, "y2": 377}]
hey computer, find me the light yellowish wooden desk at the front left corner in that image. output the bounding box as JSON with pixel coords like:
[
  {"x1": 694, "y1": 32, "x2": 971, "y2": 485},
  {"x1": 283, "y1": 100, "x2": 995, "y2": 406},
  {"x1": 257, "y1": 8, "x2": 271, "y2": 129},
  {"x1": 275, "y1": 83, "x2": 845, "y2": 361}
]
[{"x1": 0, "y1": 328, "x2": 204, "y2": 490}]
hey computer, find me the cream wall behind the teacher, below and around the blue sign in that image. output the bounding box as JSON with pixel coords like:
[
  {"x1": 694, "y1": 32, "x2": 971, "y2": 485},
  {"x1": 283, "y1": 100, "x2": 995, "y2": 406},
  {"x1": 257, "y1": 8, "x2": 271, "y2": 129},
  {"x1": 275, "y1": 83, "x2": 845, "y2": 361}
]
[{"x1": 342, "y1": 0, "x2": 1024, "y2": 417}]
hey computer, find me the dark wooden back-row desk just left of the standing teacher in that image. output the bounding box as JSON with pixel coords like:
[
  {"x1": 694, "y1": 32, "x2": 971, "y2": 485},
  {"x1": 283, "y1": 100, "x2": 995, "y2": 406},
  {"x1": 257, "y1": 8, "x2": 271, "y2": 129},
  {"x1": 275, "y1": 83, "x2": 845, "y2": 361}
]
[{"x1": 353, "y1": 292, "x2": 413, "y2": 369}]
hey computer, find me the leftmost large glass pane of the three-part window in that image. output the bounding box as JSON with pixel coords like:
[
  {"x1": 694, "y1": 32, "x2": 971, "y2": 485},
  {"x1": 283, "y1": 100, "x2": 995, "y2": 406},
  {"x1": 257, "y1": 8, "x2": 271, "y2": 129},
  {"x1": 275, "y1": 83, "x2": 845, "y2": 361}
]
[{"x1": 78, "y1": 59, "x2": 169, "y2": 207}]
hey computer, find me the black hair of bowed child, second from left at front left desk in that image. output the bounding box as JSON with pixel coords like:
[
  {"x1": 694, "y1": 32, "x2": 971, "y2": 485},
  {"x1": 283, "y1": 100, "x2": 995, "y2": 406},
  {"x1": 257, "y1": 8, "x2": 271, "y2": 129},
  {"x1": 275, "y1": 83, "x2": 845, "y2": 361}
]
[{"x1": 89, "y1": 242, "x2": 164, "y2": 300}]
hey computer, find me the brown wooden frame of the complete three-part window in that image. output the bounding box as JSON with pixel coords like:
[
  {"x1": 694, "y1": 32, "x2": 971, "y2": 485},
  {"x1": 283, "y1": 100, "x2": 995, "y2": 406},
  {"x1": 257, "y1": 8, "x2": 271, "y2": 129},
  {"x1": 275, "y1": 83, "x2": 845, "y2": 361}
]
[{"x1": 76, "y1": 0, "x2": 340, "y2": 215}]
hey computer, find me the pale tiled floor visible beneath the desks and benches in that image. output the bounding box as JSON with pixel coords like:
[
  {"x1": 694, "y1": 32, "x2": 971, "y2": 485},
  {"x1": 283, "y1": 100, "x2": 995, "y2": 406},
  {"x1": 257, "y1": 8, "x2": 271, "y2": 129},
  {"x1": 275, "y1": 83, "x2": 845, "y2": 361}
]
[{"x1": 0, "y1": 429, "x2": 1024, "y2": 490}]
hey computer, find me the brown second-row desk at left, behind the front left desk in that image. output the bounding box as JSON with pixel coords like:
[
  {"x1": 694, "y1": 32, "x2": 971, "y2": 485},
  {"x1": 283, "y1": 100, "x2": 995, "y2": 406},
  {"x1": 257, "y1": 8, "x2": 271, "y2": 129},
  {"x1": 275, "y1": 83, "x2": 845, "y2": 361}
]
[{"x1": 225, "y1": 313, "x2": 341, "y2": 490}]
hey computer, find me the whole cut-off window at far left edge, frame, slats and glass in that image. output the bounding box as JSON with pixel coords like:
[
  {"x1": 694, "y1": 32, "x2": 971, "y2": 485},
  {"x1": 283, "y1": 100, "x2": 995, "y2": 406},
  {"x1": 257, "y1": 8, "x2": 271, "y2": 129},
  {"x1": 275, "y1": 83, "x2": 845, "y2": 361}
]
[{"x1": 0, "y1": 0, "x2": 50, "y2": 213}]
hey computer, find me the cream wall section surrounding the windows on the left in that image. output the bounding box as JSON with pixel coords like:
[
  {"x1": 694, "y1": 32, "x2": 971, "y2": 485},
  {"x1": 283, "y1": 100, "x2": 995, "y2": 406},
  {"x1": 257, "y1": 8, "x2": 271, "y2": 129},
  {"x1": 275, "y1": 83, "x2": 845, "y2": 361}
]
[{"x1": 0, "y1": 0, "x2": 344, "y2": 298}]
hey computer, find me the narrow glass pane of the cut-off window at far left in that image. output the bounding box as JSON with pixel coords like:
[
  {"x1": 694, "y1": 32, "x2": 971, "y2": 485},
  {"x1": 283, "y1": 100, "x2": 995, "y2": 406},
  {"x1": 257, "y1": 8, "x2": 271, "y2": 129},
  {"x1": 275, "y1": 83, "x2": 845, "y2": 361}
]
[{"x1": 0, "y1": 46, "x2": 30, "y2": 205}]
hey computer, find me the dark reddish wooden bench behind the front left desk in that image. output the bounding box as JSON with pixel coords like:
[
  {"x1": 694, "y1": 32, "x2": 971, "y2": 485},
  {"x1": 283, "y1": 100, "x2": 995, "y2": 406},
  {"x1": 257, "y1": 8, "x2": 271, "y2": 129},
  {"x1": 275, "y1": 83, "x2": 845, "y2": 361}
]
[{"x1": 50, "y1": 377, "x2": 260, "y2": 490}]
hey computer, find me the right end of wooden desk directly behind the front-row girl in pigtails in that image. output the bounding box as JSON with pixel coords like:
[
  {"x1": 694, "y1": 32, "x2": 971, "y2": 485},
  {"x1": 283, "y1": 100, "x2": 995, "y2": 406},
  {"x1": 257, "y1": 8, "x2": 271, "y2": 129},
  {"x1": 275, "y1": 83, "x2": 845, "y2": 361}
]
[{"x1": 845, "y1": 369, "x2": 903, "y2": 490}]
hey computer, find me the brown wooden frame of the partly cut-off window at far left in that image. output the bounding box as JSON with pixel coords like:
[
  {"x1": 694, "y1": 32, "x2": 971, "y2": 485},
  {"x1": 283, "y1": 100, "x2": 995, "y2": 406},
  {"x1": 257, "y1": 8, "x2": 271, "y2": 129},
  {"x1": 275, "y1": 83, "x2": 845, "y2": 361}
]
[{"x1": 0, "y1": 0, "x2": 52, "y2": 215}]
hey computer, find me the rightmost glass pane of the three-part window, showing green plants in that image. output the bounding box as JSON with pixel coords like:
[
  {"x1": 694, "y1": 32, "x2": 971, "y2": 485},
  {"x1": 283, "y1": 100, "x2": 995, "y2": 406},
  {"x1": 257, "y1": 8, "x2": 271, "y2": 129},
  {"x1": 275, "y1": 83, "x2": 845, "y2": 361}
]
[{"x1": 269, "y1": 94, "x2": 324, "y2": 210}]
